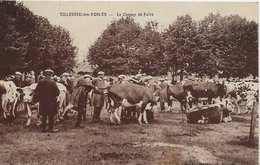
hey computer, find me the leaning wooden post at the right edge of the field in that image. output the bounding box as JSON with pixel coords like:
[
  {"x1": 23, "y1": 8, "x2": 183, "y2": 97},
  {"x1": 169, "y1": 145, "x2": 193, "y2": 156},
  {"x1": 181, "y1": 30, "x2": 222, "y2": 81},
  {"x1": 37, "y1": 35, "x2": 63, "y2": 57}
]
[{"x1": 249, "y1": 102, "x2": 258, "y2": 145}]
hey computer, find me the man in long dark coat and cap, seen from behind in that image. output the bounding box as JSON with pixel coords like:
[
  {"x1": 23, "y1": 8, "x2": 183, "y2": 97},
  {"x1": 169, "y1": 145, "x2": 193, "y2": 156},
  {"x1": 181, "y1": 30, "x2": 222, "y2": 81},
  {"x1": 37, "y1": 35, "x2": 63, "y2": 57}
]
[{"x1": 35, "y1": 69, "x2": 60, "y2": 132}]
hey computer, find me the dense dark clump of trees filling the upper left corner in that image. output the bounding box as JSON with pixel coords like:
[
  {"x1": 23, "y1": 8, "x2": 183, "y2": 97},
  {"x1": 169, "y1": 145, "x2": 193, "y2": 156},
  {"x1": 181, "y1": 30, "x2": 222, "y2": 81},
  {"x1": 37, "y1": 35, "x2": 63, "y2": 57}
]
[{"x1": 0, "y1": 1, "x2": 77, "y2": 77}]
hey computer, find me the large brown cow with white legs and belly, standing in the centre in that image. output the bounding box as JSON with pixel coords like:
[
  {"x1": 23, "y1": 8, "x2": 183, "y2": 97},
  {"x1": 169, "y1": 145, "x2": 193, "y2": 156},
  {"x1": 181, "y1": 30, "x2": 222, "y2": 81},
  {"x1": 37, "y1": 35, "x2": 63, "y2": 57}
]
[{"x1": 107, "y1": 83, "x2": 157, "y2": 124}]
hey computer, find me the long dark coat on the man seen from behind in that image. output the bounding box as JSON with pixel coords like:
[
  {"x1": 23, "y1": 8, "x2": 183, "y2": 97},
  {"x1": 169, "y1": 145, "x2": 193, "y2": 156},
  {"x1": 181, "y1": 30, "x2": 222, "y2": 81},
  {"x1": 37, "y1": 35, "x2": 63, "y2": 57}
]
[{"x1": 35, "y1": 78, "x2": 60, "y2": 115}]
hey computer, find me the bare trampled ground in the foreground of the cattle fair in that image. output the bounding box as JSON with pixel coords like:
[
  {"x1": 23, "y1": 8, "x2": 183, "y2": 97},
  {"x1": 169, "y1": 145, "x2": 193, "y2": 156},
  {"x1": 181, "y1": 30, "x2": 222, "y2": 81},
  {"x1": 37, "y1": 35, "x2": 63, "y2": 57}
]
[{"x1": 0, "y1": 100, "x2": 258, "y2": 165}]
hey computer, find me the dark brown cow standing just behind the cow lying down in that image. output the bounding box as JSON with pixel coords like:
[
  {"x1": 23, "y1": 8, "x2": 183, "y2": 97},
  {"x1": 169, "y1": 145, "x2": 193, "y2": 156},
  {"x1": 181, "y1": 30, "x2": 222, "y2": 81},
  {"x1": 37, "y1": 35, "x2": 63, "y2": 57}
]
[{"x1": 183, "y1": 82, "x2": 226, "y2": 107}]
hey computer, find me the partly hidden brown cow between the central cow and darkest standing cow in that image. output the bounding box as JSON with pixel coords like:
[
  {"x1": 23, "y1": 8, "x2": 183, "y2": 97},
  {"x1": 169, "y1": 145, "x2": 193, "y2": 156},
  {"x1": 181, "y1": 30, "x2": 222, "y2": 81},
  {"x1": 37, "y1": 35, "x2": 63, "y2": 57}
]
[{"x1": 160, "y1": 85, "x2": 187, "y2": 111}]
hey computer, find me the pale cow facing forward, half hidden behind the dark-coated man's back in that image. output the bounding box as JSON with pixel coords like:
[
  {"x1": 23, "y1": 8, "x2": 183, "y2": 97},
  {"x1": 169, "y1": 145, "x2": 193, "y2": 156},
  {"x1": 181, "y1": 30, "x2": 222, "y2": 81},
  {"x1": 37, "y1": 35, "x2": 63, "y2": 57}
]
[{"x1": 17, "y1": 83, "x2": 67, "y2": 126}]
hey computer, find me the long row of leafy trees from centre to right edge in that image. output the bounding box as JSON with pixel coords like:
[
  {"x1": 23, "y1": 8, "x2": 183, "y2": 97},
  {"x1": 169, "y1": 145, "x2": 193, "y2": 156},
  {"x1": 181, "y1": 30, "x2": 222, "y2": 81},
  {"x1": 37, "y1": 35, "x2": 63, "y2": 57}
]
[{"x1": 87, "y1": 13, "x2": 258, "y2": 79}]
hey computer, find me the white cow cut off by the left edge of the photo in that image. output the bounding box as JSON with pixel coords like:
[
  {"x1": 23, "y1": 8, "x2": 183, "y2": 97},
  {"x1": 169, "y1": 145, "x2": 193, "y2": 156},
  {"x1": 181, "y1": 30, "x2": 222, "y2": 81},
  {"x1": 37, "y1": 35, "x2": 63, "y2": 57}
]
[{"x1": 0, "y1": 81, "x2": 19, "y2": 118}]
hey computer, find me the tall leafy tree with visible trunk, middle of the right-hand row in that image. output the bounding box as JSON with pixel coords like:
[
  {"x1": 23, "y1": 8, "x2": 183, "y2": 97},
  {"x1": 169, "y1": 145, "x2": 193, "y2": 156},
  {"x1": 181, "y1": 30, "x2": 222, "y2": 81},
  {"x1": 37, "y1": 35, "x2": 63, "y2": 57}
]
[{"x1": 163, "y1": 15, "x2": 197, "y2": 80}]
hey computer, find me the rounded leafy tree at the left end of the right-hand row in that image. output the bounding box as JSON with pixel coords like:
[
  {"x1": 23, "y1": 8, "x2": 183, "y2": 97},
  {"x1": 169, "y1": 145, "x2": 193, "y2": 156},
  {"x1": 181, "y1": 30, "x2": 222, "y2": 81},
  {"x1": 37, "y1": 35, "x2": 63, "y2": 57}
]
[{"x1": 88, "y1": 17, "x2": 142, "y2": 75}]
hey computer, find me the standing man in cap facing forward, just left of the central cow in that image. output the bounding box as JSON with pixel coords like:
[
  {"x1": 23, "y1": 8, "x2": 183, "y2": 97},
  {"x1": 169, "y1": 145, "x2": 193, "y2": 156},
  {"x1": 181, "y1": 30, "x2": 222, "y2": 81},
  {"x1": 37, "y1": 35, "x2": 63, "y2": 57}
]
[{"x1": 92, "y1": 71, "x2": 106, "y2": 122}]
